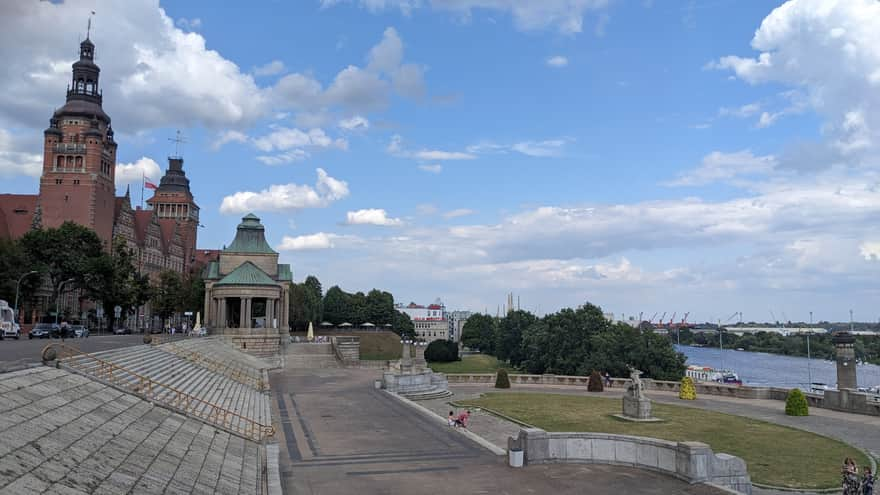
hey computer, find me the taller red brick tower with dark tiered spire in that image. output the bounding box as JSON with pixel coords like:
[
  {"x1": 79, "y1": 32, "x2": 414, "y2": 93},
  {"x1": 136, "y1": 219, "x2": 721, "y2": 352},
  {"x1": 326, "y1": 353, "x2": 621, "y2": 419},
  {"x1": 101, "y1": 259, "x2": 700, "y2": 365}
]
[{"x1": 38, "y1": 37, "x2": 116, "y2": 249}]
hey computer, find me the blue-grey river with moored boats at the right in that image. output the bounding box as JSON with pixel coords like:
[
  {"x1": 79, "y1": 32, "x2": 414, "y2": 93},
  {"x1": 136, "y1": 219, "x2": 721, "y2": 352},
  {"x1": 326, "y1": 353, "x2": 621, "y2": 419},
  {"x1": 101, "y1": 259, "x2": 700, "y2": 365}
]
[{"x1": 675, "y1": 345, "x2": 880, "y2": 389}]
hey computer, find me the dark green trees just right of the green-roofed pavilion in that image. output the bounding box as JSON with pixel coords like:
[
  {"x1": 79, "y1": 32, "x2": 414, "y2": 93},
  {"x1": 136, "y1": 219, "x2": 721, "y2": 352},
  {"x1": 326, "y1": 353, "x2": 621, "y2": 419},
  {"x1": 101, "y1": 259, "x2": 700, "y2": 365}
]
[{"x1": 290, "y1": 275, "x2": 415, "y2": 337}]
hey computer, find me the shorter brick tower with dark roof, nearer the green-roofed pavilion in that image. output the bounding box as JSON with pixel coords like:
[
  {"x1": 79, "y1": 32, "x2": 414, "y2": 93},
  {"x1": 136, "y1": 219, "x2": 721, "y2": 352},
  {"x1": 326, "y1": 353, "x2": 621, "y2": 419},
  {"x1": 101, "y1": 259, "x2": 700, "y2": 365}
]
[{"x1": 147, "y1": 156, "x2": 199, "y2": 271}]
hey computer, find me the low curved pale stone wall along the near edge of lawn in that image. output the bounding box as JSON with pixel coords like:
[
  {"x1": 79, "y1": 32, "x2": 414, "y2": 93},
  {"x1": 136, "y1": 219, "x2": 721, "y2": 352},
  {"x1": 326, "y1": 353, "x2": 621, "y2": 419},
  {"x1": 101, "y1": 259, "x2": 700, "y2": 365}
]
[{"x1": 508, "y1": 428, "x2": 752, "y2": 494}]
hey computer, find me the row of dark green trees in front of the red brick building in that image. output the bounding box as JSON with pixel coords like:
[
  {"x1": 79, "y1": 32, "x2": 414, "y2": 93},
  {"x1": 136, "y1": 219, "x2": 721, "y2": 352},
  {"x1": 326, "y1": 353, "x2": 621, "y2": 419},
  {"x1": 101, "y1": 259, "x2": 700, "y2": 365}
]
[{"x1": 0, "y1": 222, "x2": 204, "y2": 329}]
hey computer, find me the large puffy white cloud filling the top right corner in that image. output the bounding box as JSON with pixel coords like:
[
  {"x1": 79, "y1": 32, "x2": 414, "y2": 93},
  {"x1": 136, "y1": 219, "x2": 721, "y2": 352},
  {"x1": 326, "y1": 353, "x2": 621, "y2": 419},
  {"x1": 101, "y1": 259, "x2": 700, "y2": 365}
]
[{"x1": 710, "y1": 0, "x2": 880, "y2": 156}]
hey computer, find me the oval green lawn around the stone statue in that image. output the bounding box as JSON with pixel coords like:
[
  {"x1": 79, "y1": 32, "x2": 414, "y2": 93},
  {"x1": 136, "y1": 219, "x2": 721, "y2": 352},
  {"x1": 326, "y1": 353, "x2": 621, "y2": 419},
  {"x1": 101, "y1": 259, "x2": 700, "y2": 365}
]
[{"x1": 460, "y1": 393, "x2": 870, "y2": 489}]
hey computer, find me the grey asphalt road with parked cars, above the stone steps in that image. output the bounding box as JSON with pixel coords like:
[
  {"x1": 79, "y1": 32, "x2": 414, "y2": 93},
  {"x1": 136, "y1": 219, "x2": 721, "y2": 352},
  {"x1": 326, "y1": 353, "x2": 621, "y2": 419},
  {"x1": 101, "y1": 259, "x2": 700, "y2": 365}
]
[{"x1": 0, "y1": 335, "x2": 150, "y2": 373}]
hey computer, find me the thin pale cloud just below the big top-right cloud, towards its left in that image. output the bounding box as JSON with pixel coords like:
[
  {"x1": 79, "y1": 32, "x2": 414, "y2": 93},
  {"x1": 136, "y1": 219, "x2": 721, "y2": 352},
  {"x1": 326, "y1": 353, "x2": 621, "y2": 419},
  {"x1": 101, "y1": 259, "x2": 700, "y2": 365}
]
[{"x1": 666, "y1": 150, "x2": 777, "y2": 186}]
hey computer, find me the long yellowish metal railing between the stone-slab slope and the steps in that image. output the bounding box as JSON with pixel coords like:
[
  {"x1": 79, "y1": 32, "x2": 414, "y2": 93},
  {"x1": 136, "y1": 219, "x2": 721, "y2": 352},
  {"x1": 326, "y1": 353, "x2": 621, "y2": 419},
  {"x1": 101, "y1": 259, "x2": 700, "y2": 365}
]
[{"x1": 42, "y1": 343, "x2": 275, "y2": 442}]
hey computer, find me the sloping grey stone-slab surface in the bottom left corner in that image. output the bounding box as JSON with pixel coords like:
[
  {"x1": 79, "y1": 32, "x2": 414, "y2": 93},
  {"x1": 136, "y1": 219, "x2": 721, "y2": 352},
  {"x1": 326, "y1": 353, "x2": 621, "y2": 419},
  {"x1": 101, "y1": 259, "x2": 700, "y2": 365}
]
[{"x1": 0, "y1": 366, "x2": 267, "y2": 495}]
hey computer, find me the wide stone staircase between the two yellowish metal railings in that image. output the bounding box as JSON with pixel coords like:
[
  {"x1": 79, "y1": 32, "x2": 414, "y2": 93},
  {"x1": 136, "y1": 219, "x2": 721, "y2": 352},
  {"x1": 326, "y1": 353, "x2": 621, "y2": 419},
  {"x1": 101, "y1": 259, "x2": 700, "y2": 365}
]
[{"x1": 59, "y1": 345, "x2": 272, "y2": 440}]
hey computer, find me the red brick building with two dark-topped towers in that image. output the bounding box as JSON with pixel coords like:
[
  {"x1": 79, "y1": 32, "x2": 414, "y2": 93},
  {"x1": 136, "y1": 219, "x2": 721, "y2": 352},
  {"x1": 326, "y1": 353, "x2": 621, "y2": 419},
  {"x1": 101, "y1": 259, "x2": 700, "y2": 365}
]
[{"x1": 0, "y1": 38, "x2": 199, "y2": 277}]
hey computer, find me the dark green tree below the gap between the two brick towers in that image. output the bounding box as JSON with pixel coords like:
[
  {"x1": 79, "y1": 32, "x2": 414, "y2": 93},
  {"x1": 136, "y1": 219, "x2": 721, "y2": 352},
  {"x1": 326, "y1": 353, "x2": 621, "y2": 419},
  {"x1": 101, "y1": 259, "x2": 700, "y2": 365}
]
[{"x1": 84, "y1": 239, "x2": 151, "y2": 331}]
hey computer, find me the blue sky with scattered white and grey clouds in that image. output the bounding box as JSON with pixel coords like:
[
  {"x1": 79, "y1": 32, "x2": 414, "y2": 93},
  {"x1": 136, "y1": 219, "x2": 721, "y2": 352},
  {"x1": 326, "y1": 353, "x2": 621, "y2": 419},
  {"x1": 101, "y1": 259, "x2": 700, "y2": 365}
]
[{"x1": 0, "y1": 0, "x2": 880, "y2": 322}]
